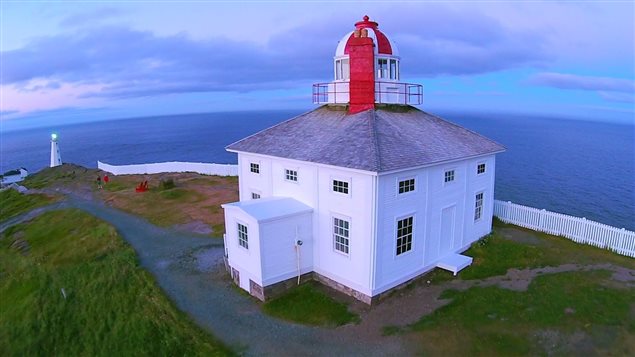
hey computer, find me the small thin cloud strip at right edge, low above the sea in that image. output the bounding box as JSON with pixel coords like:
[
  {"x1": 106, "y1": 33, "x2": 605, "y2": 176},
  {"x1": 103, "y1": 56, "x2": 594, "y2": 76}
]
[{"x1": 529, "y1": 72, "x2": 635, "y2": 93}]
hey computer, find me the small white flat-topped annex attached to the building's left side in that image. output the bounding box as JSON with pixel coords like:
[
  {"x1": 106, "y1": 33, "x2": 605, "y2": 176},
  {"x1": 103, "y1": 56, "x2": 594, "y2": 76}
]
[{"x1": 223, "y1": 197, "x2": 313, "y2": 300}]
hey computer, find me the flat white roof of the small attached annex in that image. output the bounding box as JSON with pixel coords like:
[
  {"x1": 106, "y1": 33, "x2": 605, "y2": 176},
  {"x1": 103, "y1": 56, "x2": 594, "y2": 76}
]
[{"x1": 222, "y1": 197, "x2": 313, "y2": 222}]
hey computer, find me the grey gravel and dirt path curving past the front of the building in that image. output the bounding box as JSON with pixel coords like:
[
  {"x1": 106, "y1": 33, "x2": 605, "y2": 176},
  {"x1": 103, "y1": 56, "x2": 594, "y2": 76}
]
[{"x1": 0, "y1": 197, "x2": 635, "y2": 356}]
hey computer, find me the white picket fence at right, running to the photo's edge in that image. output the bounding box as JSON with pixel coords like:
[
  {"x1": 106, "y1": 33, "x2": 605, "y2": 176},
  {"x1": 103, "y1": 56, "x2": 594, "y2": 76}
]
[{"x1": 494, "y1": 200, "x2": 635, "y2": 257}]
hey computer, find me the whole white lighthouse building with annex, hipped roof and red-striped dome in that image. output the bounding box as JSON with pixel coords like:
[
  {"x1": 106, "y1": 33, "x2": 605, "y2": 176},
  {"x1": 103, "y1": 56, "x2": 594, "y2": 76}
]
[{"x1": 223, "y1": 17, "x2": 504, "y2": 303}]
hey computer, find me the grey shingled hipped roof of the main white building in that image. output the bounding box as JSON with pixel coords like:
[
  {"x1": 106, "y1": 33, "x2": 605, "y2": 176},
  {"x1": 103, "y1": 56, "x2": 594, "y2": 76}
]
[{"x1": 226, "y1": 105, "x2": 505, "y2": 172}]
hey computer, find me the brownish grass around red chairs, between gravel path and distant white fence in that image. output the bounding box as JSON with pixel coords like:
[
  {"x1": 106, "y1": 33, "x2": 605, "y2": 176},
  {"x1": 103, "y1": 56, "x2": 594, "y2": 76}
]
[{"x1": 24, "y1": 164, "x2": 238, "y2": 237}]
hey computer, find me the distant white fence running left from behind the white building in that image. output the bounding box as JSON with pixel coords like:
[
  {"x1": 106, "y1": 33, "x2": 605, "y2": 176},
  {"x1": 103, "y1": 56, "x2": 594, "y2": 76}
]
[{"x1": 97, "y1": 161, "x2": 238, "y2": 176}]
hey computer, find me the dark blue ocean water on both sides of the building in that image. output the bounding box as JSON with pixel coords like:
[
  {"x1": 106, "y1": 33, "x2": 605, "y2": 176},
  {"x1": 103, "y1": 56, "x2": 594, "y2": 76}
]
[{"x1": 0, "y1": 111, "x2": 635, "y2": 230}]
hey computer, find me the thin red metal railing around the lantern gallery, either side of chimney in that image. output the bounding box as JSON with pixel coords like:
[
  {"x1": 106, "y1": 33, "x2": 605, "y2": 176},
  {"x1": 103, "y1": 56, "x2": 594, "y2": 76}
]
[{"x1": 313, "y1": 82, "x2": 423, "y2": 105}]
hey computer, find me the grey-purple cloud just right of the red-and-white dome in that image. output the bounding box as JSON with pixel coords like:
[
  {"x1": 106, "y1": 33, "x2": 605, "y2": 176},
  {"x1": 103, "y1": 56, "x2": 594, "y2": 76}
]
[{"x1": 382, "y1": 5, "x2": 552, "y2": 77}]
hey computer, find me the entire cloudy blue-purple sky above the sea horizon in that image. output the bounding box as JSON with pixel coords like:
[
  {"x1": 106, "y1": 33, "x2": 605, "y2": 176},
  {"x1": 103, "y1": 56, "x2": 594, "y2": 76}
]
[{"x1": 0, "y1": 0, "x2": 635, "y2": 129}]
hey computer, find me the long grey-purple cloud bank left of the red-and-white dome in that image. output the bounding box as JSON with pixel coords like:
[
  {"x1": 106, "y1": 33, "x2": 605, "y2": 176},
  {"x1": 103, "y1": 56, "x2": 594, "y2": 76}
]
[{"x1": 2, "y1": 26, "x2": 331, "y2": 97}]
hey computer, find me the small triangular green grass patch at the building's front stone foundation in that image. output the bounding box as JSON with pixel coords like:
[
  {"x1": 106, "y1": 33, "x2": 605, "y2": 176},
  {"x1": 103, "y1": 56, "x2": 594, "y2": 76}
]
[{"x1": 263, "y1": 282, "x2": 359, "y2": 327}]
